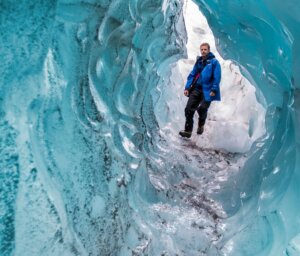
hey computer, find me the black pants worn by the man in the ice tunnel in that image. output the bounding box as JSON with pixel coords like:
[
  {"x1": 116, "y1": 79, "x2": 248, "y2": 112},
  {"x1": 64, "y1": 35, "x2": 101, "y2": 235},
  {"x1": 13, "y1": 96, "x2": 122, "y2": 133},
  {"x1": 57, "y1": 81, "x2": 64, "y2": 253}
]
[{"x1": 185, "y1": 88, "x2": 211, "y2": 132}]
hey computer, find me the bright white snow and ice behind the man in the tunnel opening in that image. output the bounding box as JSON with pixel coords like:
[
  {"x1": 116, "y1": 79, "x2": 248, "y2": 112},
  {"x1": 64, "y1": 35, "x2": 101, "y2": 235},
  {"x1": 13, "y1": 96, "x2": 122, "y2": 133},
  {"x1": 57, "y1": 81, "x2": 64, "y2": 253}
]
[{"x1": 163, "y1": 0, "x2": 266, "y2": 153}]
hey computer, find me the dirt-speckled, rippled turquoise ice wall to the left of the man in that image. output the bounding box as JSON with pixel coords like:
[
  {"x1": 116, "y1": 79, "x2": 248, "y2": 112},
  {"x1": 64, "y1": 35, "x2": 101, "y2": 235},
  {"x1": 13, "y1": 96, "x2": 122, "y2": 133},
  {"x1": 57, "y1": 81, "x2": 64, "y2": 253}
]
[{"x1": 0, "y1": 1, "x2": 190, "y2": 255}]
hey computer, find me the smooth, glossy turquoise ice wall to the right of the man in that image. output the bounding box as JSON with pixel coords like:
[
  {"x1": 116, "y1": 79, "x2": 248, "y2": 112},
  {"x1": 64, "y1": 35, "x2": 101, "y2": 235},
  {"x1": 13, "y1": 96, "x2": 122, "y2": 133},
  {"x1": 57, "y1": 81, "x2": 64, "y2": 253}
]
[{"x1": 197, "y1": 0, "x2": 300, "y2": 255}]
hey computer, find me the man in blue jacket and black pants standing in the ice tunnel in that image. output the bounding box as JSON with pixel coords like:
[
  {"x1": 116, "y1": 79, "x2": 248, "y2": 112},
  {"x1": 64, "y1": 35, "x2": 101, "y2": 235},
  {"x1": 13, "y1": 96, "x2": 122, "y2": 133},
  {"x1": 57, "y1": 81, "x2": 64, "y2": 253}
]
[{"x1": 179, "y1": 43, "x2": 221, "y2": 138}]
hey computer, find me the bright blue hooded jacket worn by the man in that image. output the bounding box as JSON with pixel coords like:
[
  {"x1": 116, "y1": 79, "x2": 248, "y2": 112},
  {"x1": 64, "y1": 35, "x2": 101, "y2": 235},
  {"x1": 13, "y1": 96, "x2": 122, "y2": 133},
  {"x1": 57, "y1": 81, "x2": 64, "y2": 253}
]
[{"x1": 185, "y1": 52, "x2": 221, "y2": 101}]
